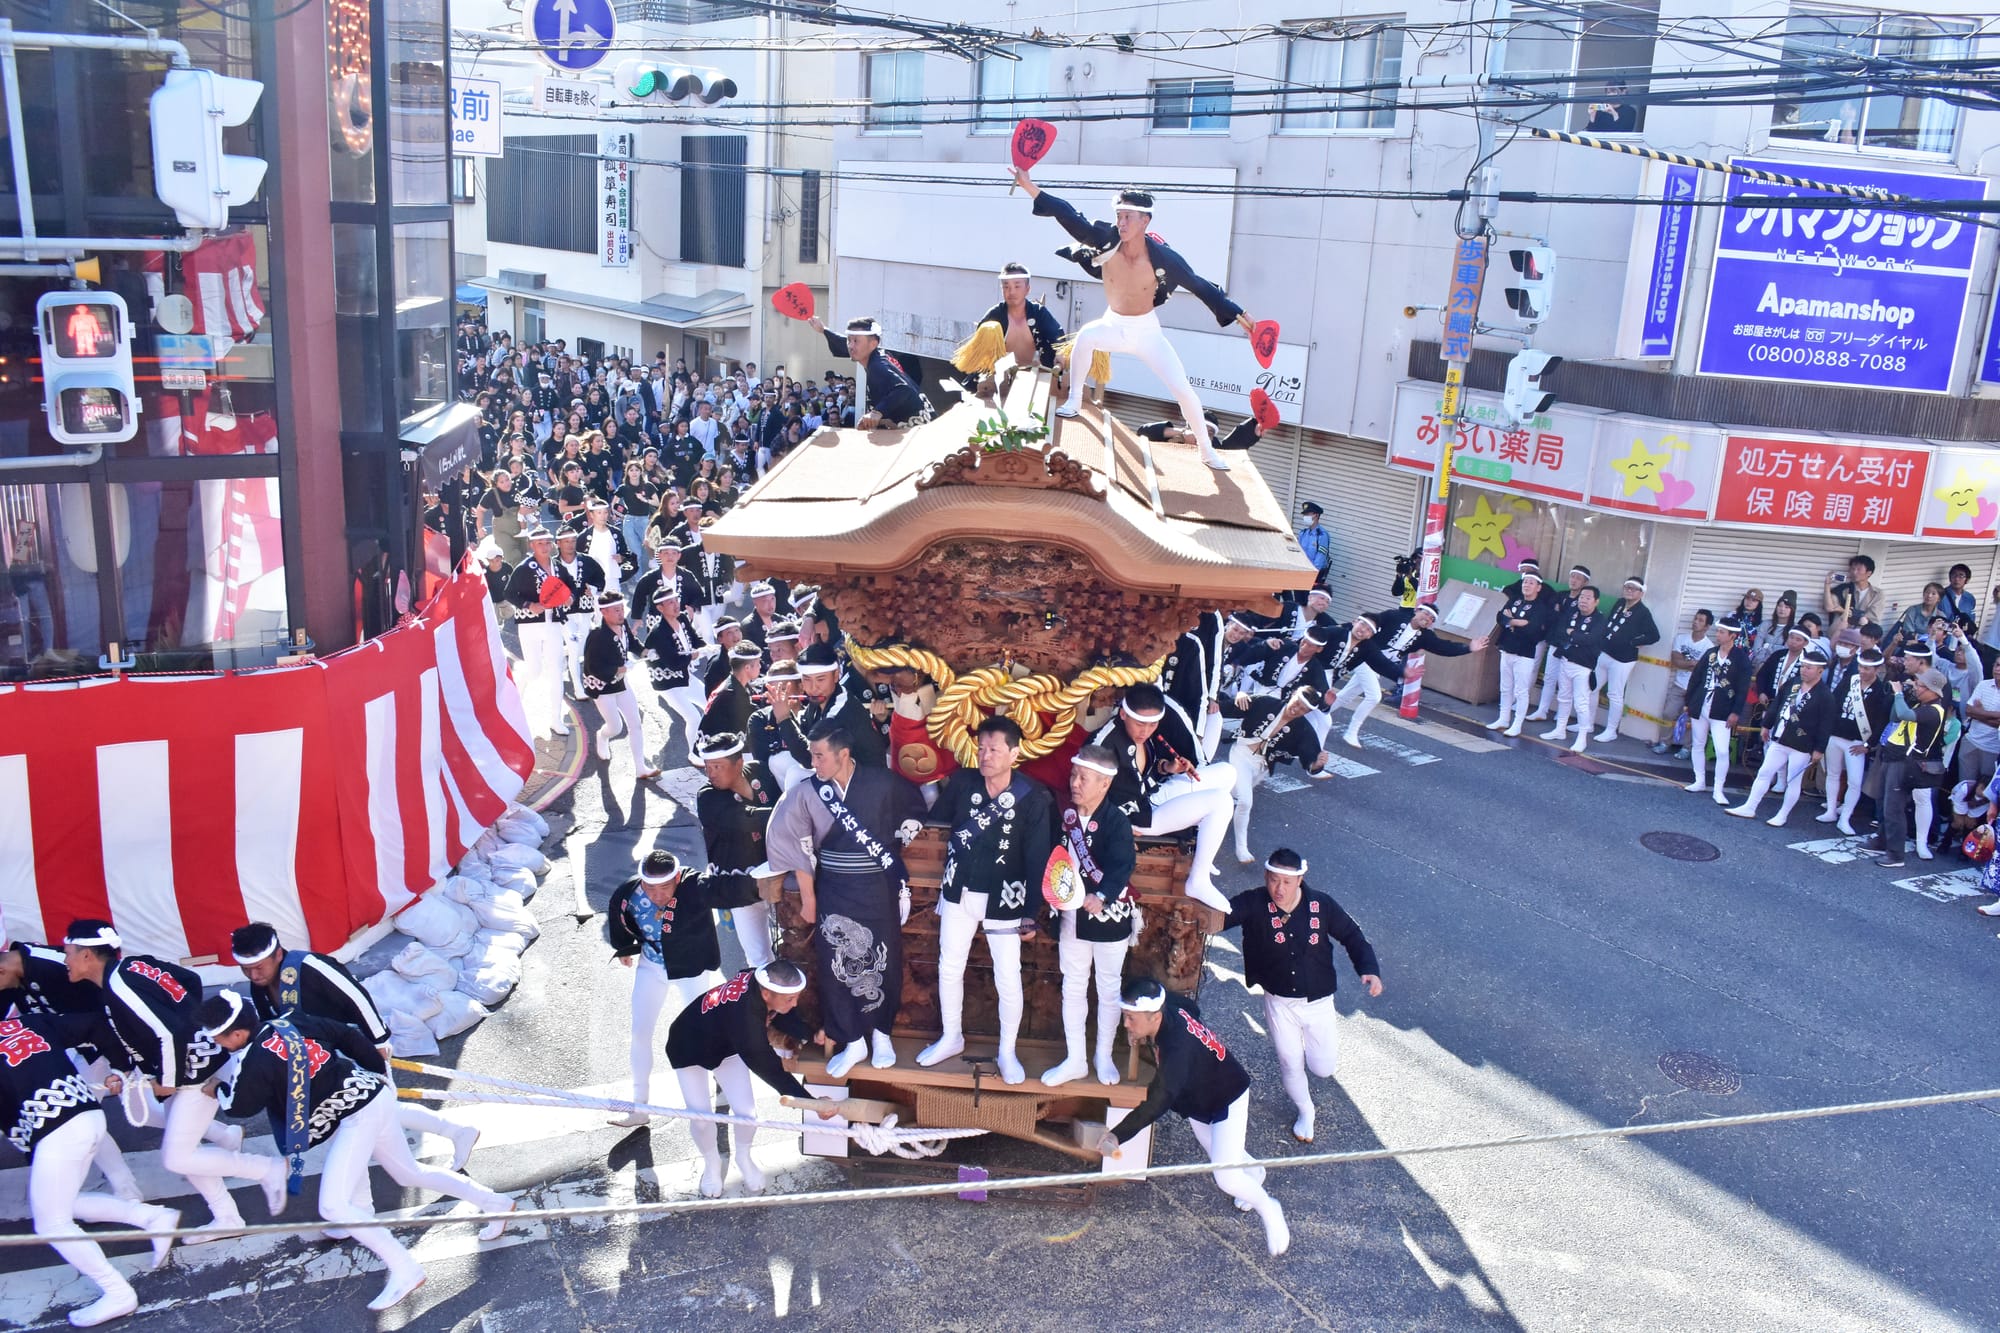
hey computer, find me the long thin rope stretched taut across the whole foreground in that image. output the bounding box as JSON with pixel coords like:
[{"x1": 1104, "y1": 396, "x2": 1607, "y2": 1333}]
[{"x1": 0, "y1": 1087, "x2": 2000, "y2": 1249}]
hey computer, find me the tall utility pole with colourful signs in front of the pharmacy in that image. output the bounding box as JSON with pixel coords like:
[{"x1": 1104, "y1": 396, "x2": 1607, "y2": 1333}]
[{"x1": 1398, "y1": 0, "x2": 1514, "y2": 719}]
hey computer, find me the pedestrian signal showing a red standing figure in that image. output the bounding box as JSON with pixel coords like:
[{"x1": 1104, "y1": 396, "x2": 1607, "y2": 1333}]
[{"x1": 34, "y1": 292, "x2": 138, "y2": 444}]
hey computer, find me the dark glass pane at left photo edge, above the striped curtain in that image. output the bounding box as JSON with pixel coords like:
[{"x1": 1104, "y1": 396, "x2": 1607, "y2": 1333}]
[{"x1": 0, "y1": 484, "x2": 104, "y2": 681}]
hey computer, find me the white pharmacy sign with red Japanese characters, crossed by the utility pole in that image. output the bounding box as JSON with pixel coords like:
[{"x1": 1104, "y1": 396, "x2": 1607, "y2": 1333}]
[{"x1": 1388, "y1": 380, "x2": 1604, "y2": 504}]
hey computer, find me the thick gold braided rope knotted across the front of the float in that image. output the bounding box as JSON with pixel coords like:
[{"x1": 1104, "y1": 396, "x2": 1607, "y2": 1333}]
[{"x1": 848, "y1": 642, "x2": 1166, "y2": 769}]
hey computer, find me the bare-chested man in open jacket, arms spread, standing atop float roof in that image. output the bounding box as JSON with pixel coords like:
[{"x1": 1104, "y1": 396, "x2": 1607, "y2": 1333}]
[{"x1": 1014, "y1": 168, "x2": 1252, "y2": 472}]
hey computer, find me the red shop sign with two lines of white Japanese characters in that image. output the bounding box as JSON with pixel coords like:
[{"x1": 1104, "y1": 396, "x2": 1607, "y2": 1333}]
[{"x1": 1716, "y1": 434, "x2": 1930, "y2": 536}]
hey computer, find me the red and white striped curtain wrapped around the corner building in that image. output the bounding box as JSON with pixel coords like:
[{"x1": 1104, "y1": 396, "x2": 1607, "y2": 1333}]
[{"x1": 0, "y1": 574, "x2": 534, "y2": 959}]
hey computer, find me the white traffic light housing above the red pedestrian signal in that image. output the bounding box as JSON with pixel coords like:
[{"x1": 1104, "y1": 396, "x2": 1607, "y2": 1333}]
[{"x1": 150, "y1": 70, "x2": 266, "y2": 232}]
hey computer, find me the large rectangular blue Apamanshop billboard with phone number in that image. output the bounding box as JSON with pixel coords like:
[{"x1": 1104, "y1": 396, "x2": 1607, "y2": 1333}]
[{"x1": 1696, "y1": 158, "x2": 1988, "y2": 394}]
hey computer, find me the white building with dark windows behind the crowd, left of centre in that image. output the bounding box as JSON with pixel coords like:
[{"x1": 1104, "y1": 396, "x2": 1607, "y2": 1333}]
[{"x1": 452, "y1": 0, "x2": 832, "y2": 368}]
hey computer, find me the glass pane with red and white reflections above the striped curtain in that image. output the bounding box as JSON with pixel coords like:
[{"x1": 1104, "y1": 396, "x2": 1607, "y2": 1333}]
[{"x1": 110, "y1": 476, "x2": 288, "y2": 671}]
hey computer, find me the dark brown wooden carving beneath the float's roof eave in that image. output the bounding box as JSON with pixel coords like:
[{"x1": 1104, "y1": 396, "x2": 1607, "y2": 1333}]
[{"x1": 804, "y1": 536, "x2": 1208, "y2": 677}]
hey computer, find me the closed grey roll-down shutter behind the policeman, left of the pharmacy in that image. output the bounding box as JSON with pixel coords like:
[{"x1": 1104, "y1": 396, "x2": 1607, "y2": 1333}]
[{"x1": 1292, "y1": 430, "x2": 1424, "y2": 620}]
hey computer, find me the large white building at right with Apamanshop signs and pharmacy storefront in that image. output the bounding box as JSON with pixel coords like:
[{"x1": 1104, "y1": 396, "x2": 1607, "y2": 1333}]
[{"x1": 834, "y1": 0, "x2": 2000, "y2": 737}]
